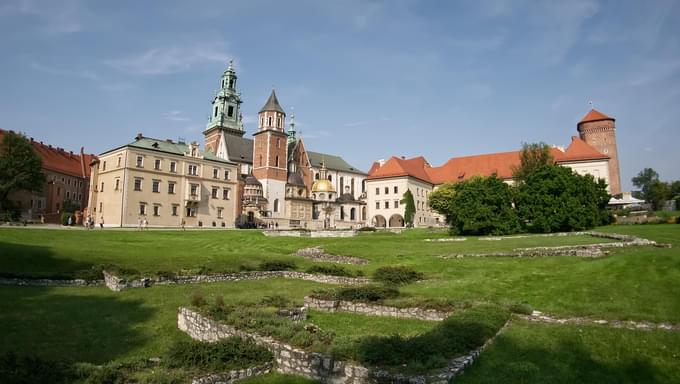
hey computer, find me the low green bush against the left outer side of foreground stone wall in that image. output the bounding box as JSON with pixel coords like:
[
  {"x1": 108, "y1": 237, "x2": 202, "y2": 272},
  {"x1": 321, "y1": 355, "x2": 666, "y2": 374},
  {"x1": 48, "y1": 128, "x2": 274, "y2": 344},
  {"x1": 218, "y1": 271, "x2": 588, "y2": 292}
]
[{"x1": 165, "y1": 337, "x2": 273, "y2": 372}]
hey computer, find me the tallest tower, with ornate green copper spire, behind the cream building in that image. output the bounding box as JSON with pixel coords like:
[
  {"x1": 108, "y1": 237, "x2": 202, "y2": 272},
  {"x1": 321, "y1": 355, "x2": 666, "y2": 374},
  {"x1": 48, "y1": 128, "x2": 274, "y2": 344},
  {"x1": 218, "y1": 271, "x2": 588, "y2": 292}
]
[{"x1": 203, "y1": 61, "x2": 245, "y2": 156}]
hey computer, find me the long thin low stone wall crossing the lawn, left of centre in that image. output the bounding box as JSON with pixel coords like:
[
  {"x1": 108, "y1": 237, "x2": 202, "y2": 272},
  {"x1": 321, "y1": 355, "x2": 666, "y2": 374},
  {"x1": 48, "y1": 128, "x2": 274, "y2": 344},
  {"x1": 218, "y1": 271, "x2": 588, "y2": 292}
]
[{"x1": 104, "y1": 271, "x2": 371, "y2": 292}]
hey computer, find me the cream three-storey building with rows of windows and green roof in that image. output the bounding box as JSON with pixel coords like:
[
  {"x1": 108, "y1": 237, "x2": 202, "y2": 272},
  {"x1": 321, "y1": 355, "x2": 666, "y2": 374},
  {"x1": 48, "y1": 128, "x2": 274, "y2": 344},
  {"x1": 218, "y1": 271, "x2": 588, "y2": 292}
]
[{"x1": 88, "y1": 134, "x2": 238, "y2": 228}]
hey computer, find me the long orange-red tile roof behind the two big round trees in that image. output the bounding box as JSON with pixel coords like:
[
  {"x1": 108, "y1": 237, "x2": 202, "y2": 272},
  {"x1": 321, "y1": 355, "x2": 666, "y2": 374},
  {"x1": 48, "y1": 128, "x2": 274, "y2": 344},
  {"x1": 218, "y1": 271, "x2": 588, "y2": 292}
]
[{"x1": 368, "y1": 136, "x2": 609, "y2": 185}]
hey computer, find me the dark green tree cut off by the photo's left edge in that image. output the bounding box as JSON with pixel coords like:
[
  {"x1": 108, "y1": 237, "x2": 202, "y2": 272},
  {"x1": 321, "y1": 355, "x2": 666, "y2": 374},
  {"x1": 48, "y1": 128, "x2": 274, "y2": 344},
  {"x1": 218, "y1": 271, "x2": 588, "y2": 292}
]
[{"x1": 0, "y1": 131, "x2": 45, "y2": 211}]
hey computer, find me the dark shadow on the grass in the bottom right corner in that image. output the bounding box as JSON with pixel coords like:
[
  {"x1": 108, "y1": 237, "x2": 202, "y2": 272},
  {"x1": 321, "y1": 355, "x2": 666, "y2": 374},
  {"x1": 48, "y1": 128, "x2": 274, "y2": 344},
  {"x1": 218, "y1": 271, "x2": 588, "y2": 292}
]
[{"x1": 456, "y1": 336, "x2": 669, "y2": 384}]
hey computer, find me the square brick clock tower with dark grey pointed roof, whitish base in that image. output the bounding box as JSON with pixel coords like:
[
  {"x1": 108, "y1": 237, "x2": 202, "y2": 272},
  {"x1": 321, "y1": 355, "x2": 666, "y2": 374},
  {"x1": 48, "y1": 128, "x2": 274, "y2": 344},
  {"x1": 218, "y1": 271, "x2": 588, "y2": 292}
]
[{"x1": 253, "y1": 90, "x2": 288, "y2": 218}]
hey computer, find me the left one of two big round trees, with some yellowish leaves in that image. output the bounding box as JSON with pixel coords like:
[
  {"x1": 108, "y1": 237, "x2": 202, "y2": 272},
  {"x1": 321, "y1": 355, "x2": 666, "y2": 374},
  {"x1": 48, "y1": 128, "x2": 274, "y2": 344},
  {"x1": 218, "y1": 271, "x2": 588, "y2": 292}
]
[{"x1": 430, "y1": 176, "x2": 520, "y2": 235}]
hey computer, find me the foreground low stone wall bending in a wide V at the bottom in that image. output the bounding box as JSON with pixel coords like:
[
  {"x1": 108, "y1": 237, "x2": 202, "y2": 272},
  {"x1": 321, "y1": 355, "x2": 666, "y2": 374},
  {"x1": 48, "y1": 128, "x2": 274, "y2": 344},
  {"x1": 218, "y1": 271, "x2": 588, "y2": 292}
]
[{"x1": 177, "y1": 308, "x2": 509, "y2": 384}]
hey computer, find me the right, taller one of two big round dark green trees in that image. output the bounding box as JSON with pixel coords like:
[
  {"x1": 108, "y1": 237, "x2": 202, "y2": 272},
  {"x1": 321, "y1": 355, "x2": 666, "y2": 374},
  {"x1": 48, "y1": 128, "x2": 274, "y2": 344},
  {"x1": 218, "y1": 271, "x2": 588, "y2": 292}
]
[{"x1": 517, "y1": 165, "x2": 610, "y2": 232}]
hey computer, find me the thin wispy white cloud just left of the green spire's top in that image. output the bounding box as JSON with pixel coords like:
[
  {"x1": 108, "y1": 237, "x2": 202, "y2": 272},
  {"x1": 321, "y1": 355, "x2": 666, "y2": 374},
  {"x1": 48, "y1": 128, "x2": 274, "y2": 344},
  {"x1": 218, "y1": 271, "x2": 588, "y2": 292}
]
[{"x1": 105, "y1": 44, "x2": 231, "y2": 75}]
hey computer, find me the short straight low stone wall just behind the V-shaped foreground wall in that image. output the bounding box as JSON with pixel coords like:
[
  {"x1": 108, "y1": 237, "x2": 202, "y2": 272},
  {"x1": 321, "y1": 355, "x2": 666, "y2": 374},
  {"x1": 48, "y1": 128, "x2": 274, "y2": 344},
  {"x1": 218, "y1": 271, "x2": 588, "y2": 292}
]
[{"x1": 305, "y1": 296, "x2": 453, "y2": 321}]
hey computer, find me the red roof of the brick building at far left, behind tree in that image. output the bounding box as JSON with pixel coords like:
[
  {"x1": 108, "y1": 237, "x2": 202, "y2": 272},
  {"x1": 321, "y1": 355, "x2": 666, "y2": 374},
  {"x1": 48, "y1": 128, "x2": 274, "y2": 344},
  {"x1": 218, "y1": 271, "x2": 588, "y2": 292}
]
[{"x1": 0, "y1": 129, "x2": 97, "y2": 177}]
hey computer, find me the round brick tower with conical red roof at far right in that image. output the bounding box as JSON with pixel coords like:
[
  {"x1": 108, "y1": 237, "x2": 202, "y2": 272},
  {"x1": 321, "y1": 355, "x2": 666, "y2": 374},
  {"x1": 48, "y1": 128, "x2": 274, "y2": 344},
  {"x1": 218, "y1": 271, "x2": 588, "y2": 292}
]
[{"x1": 576, "y1": 109, "x2": 621, "y2": 195}]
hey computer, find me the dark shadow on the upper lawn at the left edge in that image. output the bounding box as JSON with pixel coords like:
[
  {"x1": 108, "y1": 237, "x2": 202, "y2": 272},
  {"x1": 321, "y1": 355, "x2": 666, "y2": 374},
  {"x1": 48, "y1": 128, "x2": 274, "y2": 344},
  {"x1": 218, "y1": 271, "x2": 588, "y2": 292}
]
[{"x1": 0, "y1": 241, "x2": 97, "y2": 280}]
